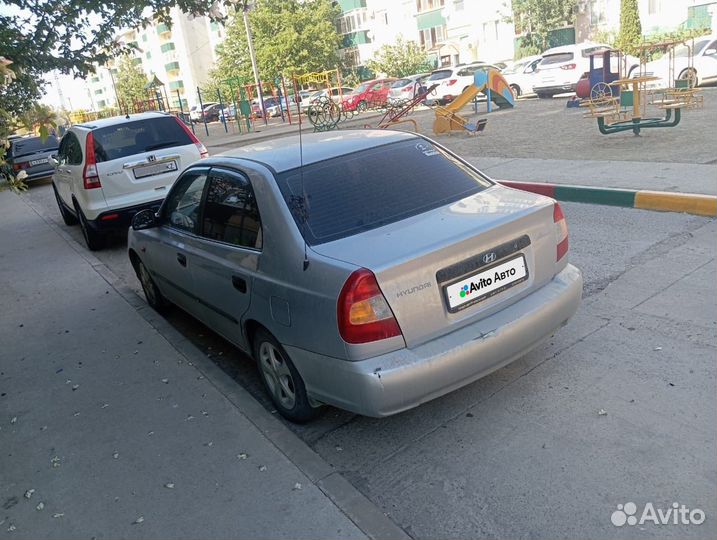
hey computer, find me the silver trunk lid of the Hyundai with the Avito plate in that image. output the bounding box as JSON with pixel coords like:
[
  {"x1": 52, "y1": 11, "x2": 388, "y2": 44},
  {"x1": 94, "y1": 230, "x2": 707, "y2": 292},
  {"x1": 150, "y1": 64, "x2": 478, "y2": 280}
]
[{"x1": 312, "y1": 186, "x2": 556, "y2": 347}]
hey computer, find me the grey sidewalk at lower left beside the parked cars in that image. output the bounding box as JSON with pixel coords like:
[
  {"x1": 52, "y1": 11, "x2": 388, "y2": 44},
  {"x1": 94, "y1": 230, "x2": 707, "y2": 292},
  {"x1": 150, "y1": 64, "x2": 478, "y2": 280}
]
[{"x1": 0, "y1": 191, "x2": 405, "y2": 539}]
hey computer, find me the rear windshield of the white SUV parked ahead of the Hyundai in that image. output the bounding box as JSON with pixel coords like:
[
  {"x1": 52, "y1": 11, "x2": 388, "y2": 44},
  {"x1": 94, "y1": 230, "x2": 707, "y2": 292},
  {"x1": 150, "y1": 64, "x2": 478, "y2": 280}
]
[{"x1": 92, "y1": 116, "x2": 192, "y2": 163}]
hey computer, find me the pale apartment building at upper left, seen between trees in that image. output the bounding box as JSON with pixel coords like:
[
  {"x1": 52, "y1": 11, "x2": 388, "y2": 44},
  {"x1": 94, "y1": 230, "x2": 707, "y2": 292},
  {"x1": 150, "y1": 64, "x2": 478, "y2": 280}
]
[{"x1": 87, "y1": 7, "x2": 225, "y2": 110}]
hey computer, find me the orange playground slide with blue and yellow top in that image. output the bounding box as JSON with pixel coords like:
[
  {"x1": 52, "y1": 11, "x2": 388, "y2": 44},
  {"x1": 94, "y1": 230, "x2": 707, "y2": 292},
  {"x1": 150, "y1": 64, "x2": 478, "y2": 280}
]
[{"x1": 433, "y1": 68, "x2": 515, "y2": 135}]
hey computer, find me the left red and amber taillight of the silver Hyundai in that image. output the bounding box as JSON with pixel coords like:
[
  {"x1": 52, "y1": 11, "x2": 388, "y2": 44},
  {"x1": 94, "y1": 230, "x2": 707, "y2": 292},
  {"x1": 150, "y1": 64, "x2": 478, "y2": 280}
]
[{"x1": 337, "y1": 268, "x2": 401, "y2": 343}]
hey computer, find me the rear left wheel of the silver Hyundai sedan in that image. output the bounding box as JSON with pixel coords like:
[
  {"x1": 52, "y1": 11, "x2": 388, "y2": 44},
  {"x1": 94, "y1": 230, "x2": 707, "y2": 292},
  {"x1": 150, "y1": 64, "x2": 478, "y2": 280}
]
[{"x1": 253, "y1": 328, "x2": 319, "y2": 423}]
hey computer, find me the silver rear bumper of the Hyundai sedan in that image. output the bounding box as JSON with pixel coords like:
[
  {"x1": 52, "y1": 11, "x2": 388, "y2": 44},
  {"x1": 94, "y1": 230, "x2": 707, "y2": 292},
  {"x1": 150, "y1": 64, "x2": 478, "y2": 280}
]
[{"x1": 285, "y1": 265, "x2": 583, "y2": 417}]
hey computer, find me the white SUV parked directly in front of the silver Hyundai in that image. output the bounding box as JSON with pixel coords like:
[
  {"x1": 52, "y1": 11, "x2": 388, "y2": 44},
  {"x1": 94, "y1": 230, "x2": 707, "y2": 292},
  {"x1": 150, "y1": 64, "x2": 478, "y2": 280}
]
[{"x1": 51, "y1": 112, "x2": 208, "y2": 250}]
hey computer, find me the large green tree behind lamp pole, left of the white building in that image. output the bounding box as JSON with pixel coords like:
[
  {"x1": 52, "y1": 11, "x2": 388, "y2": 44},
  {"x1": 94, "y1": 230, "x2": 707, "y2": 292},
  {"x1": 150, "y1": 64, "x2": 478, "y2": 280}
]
[{"x1": 210, "y1": 0, "x2": 341, "y2": 82}]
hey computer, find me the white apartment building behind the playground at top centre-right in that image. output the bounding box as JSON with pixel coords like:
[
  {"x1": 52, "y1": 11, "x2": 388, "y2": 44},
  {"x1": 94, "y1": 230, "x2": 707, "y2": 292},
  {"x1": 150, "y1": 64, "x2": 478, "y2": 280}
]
[{"x1": 338, "y1": 0, "x2": 515, "y2": 72}]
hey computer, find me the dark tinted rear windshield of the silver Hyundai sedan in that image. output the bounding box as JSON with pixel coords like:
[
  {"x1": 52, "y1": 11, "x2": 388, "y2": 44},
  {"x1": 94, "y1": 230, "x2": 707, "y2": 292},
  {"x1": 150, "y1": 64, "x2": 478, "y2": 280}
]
[{"x1": 277, "y1": 139, "x2": 491, "y2": 245}]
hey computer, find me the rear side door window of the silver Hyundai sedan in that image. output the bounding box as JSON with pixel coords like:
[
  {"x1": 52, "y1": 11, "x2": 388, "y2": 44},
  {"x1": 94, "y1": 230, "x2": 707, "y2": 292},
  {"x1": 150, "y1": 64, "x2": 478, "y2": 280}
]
[{"x1": 202, "y1": 170, "x2": 262, "y2": 249}]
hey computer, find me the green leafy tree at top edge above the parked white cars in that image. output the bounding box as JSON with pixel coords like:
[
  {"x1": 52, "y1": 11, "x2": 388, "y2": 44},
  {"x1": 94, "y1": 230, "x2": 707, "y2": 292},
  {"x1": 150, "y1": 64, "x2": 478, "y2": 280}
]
[{"x1": 506, "y1": 0, "x2": 578, "y2": 52}]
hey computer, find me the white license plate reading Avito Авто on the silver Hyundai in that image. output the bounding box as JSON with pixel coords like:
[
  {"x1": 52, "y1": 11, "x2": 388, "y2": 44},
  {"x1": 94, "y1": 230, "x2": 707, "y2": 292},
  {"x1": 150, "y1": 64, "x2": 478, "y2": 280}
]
[{"x1": 444, "y1": 254, "x2": 528, "y2": 311}]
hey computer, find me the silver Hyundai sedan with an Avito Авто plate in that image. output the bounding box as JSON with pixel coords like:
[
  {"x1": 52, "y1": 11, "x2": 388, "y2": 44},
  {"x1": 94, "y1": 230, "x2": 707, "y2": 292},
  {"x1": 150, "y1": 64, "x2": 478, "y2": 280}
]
[{"x1": 128, "y1": 130, "x2": 582, "y2": 421}]
